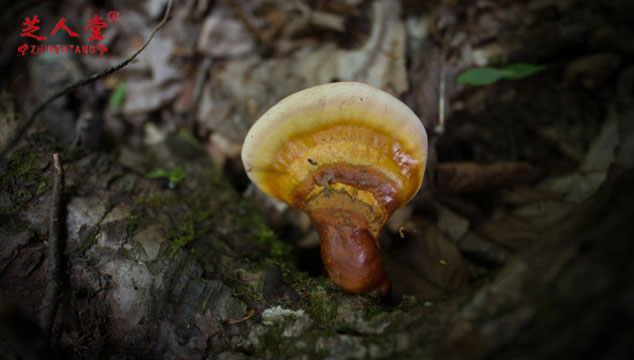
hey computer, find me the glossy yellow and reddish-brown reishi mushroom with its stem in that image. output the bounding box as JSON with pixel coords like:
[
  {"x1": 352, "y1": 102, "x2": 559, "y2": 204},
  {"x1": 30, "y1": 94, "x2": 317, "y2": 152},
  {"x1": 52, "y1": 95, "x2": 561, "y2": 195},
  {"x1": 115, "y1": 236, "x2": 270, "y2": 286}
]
[{"x1": 242, "y1": 82, "x2": 427, "y2": 295}]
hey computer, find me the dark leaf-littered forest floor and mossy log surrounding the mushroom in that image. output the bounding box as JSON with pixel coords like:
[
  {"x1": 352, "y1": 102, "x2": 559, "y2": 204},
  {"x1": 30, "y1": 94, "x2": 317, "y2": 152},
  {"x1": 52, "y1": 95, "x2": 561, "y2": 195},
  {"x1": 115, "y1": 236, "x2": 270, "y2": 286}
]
[{"x1": 0, "y1": 0, "x2": 634, "y2": 359}]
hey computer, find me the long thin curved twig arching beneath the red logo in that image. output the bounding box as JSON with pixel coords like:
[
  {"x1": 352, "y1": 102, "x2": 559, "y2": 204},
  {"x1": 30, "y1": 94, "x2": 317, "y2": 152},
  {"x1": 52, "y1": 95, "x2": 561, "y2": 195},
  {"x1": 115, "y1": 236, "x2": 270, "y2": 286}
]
[{"x1": 0, "y1": 0, "x2": 172, "y2": 163}]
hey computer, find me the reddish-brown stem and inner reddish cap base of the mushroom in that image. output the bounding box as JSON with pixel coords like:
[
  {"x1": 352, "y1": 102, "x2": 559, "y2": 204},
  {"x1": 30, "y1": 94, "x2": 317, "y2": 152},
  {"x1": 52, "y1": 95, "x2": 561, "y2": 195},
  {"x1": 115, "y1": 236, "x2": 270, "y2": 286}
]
[{"x1": 295, "y1": 164, "x2": 400, "y2": 296}]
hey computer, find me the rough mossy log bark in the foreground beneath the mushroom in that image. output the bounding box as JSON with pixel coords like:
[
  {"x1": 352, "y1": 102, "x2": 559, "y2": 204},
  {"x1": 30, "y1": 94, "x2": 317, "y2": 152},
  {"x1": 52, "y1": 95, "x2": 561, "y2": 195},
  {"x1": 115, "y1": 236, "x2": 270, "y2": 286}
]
[{"x1": 0, "y1": 131, "x2": 634, "y2": 359}]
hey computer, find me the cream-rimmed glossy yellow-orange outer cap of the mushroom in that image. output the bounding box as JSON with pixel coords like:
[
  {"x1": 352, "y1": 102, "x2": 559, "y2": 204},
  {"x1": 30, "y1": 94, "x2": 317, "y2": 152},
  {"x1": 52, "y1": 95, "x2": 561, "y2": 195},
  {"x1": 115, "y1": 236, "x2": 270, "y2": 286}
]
[{"x1": 242, "y1": 82, "x2": 427, "y2": 205}]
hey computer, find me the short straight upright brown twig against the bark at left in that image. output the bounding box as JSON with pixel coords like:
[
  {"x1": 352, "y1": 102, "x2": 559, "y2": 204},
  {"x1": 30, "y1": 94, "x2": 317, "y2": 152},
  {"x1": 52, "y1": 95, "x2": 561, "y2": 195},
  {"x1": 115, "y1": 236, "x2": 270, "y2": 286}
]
[{"x1": 40, "y1": 153, "x2": 64, "y2": 337}]
